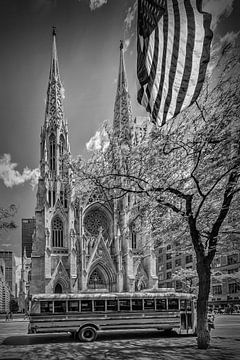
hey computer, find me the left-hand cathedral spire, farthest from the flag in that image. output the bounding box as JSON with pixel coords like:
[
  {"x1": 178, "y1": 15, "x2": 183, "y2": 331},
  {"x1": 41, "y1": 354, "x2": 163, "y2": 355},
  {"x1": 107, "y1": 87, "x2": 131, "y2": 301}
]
[{"x1": 45, "y1": 27, "x2": 64, "y2": 126}]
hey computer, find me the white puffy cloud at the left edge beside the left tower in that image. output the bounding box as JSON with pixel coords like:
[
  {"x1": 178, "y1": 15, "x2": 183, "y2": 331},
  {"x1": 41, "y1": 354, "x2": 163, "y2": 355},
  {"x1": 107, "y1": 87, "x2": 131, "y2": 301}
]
[{"x1": 0, "y1": 154, "x2": 39, "y2": 188}]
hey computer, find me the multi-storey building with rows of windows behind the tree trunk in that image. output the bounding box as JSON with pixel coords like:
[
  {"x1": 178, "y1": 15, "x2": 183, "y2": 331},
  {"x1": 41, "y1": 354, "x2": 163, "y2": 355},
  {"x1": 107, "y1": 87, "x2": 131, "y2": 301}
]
[{"x1": 157, "y1": 244, "x2": 240, "y2": 308}]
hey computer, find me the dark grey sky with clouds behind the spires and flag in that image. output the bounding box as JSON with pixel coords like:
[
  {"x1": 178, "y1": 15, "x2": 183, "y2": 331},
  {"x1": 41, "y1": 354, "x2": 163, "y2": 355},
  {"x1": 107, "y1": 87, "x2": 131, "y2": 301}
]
[{"x1": 0, "y1": 0, "x2": 240, "y2": 257}]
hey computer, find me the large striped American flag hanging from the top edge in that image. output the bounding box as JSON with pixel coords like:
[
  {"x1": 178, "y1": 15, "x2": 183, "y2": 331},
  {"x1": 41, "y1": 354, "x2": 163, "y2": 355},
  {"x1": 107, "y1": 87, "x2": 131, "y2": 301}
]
[{"x1": 137, "y1": 0, "x2": 212, "y2": 126}]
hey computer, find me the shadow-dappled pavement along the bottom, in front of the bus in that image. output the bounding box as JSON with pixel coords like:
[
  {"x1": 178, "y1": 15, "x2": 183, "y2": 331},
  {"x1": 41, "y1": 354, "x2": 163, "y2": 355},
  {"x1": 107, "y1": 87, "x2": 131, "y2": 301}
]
[{"x1": 0, "y1": 337, "x2": 240, "y2": 360}]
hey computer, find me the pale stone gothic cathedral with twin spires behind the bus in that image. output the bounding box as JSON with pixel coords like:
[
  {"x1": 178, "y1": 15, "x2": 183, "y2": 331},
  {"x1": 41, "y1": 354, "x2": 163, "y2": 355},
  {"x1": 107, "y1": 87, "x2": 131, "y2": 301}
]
[{"x1": 30, "y1": 29, "x2": 157, "y2": 294}]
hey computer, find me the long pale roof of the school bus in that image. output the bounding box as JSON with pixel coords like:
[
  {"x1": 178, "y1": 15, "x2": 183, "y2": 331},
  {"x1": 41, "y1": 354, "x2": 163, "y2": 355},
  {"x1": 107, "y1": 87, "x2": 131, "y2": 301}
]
[{"x1": 32, "y1": 291, "x2": 195, "y2": 301}]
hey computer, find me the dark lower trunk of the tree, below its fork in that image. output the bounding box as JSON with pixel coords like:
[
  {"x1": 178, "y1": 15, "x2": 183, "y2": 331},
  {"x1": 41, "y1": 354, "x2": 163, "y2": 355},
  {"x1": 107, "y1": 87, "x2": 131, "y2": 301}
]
[{"x1": 197, "y1": 256, "x2": 211, "y2": 349}]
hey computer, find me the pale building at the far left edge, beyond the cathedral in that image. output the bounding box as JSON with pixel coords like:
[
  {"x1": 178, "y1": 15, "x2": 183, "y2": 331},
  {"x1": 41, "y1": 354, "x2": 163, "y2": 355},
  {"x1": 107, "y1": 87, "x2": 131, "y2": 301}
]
[{"x1": 0, "y1": 250, "x2": 16, "y2": 296}]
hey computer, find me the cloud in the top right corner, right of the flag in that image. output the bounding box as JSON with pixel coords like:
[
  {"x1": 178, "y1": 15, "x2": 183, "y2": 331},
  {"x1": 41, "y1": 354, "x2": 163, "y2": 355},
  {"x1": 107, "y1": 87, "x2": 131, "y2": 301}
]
[{"x1": 203, "y1": 0, "x2": 234, "y2": 30}]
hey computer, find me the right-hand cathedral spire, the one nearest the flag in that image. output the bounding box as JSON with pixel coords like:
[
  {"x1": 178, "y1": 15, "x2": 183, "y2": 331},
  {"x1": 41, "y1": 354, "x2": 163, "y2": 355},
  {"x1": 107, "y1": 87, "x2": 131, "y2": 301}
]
[{"x1": 113, "y1": 40, "x2": 132, "y2": 143}]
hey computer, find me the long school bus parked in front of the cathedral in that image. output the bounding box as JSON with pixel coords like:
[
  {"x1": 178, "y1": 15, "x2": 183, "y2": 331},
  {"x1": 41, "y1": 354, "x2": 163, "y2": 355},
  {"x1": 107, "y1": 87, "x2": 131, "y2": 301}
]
[{"x1": 28, "y1": 291, "x2": 196, "y2": 342}]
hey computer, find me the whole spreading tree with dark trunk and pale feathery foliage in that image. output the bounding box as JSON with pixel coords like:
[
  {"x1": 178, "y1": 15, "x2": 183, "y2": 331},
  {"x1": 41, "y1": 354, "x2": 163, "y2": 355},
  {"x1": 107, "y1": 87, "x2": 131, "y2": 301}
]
[{"x1": 73, "y1": 39, "x2": 240, "y2": 349}]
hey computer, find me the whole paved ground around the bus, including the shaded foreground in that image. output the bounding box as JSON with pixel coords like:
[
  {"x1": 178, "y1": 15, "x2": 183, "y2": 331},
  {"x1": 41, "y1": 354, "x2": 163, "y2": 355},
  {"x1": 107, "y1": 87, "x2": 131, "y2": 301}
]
[{"x1": 0, "y1": 315, "x2": 240, "y2": 360}]
